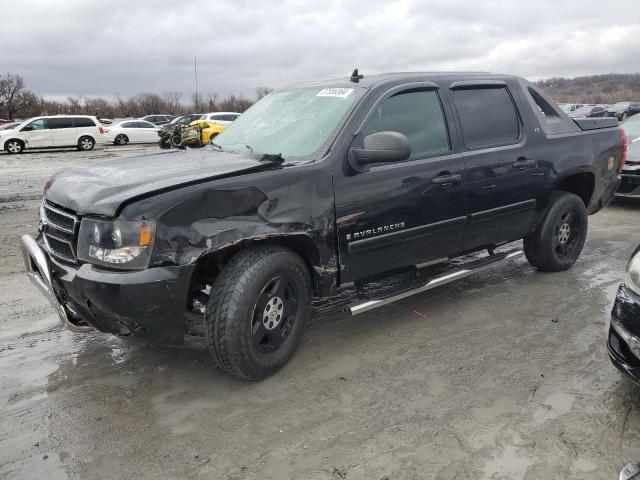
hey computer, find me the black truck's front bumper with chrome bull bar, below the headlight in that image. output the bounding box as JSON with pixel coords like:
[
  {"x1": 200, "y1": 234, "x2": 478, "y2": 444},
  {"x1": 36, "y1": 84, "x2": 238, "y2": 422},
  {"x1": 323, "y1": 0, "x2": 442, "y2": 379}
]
[{"x1": 21, "y1": 235, "x2": 194, "y2": 343}]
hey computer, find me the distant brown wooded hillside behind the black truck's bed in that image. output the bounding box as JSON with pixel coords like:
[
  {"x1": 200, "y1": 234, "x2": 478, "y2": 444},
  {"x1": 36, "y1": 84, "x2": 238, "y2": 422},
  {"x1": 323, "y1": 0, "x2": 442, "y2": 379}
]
[{"x1": 536, "y1": 73, "x2": 640, "y2": 103}]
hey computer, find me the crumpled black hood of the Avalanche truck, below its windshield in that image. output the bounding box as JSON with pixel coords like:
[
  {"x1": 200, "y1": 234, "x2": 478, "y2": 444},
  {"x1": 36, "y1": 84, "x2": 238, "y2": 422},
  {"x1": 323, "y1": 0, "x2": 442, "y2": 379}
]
[{"x1": 45, "y1": 149, "x2": 270, "y2": 217}]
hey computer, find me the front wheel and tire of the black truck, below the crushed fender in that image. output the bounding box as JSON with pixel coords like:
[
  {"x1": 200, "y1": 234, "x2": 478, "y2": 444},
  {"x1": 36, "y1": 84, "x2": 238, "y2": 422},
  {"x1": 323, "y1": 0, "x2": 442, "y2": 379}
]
[{"x1": 205, "y1": 246, "x2": 312, "y2": 380}]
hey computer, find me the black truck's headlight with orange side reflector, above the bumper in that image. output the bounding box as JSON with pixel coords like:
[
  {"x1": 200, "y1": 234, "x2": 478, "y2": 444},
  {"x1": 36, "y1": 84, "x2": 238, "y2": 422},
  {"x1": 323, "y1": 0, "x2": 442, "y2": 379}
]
[{"x1": 78, "y1": 218, "x2": 155, "y2": 269}]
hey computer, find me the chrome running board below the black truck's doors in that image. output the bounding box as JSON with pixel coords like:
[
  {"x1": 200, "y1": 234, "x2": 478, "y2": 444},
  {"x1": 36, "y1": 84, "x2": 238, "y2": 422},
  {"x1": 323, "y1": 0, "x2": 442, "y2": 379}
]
[{"x1": 348, "y1": 249, "x2": 524, "y2": 315}]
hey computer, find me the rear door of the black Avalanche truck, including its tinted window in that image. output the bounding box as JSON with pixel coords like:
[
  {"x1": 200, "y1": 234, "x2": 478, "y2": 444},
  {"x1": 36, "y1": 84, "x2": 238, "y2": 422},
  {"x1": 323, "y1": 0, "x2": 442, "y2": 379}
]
[{"x1": 450, "y1": 81, "x2": 544, "y2": 251}]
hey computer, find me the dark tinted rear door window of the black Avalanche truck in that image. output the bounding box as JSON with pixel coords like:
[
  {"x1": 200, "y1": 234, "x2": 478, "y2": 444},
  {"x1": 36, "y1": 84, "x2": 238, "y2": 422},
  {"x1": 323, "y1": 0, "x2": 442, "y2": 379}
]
[{"x1": 453, "y1": 87, "x2": 520, "y2": 149}]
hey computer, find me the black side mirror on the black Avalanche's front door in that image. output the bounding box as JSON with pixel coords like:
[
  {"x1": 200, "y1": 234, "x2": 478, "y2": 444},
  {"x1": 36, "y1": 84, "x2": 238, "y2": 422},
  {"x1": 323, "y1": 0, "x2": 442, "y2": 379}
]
[{"x1": 349, "y1": 131, "x2": 411, "y2": 172}]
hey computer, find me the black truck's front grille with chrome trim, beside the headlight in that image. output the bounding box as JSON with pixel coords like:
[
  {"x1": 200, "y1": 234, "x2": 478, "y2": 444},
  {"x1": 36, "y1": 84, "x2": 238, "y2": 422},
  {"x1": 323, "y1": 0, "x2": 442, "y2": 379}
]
[{"x1": 40, "y1": 201, "x2": 80, "y2": 264}]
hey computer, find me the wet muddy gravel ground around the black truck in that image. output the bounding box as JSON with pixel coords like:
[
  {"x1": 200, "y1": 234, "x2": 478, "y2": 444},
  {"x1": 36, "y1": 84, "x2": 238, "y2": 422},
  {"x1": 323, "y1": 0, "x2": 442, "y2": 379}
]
[{"x1": 0, "y1": 148, "x2": 640, "y2": 480}]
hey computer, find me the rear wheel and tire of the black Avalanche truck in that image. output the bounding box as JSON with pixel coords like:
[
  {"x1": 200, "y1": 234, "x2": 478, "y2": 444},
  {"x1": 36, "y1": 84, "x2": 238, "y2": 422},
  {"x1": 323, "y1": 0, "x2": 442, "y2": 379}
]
[{"x1": 523, "y1": 192, "x2": 589, "y2": 272}]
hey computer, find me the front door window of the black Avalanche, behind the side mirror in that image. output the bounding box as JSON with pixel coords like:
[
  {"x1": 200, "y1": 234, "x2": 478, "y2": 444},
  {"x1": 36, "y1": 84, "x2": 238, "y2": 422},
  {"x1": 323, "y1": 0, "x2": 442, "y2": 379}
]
[{"x1": 362, "y1": 90, "x2": 450, "y2": 159}]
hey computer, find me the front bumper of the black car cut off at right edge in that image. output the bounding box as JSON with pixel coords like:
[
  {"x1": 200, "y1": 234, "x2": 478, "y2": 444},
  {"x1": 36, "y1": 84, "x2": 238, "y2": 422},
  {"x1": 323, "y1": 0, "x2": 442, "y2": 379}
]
[{"x1": 607, "y1": 285, "x2": 640, "y2": 385}]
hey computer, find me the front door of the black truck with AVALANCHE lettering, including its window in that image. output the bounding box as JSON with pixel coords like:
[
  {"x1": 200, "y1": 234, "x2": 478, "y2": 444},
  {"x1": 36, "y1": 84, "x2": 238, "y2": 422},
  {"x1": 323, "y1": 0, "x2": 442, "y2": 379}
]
[{"x1": 335, "y1": 87, "x2": 466, "y2": 284}]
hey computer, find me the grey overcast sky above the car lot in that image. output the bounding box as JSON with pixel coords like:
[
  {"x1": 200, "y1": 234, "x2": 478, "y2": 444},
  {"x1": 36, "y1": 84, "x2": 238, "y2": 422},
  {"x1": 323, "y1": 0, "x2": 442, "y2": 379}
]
[{"x1": 5, "y1": 0, "x2": 640, "y2": 99}]
